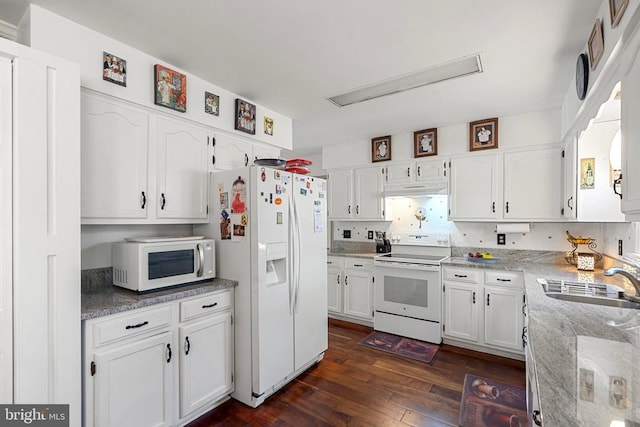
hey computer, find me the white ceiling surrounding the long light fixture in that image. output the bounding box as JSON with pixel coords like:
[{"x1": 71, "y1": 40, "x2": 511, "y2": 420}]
[{"x1": 0, "y1": 0, "x2": 602, "y2": 152}]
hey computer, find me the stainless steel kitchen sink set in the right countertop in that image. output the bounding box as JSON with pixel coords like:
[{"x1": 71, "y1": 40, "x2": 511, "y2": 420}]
[{"x1": 538, "y1": 279, "x2": 640, "y2": 309}]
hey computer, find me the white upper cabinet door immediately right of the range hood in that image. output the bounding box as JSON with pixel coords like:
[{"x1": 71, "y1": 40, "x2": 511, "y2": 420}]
[{"x1": 449, "y1": 155, "x2": 500, "y2": 220}]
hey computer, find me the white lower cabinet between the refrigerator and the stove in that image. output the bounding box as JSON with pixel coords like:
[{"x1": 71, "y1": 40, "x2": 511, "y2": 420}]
[{"x1": 327, "y1": 257, "x2": 373, "y2": 324}]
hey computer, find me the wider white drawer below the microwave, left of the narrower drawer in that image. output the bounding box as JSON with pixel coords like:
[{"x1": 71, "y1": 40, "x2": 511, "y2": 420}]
[{"x1": 93, "y1": 305, "x2": 172, "y2": 347}]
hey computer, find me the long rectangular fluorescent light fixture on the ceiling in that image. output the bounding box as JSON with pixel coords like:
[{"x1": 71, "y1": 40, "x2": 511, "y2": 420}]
[{"x1": 327, "y1": 53, "x2": 482, "y2": 107}]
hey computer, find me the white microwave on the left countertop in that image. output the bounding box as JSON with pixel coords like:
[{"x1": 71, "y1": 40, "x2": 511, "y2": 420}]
[{"x1": 112, "y1": 236, "x2": 216, "y2": 292}]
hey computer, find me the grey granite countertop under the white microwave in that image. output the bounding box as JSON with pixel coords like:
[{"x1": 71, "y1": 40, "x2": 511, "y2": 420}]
[{"x1": 81, "y1": 278, "x2": 238, "y2": 320}]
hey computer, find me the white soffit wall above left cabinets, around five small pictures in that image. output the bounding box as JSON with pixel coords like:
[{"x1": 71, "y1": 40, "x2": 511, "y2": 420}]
[{"x1": 19, "y1": 5, "x2": 293, "y2": 149}]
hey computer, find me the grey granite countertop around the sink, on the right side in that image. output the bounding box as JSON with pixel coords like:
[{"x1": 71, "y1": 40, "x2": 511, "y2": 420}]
[{"x1": 443, "y1": 257, "x2": 640, "y2": 427}]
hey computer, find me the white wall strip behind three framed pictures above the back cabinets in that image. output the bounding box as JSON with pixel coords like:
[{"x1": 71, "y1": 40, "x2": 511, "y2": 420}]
[{"x1": 322, "y1": 109, "x2": 560, "y2": 170}]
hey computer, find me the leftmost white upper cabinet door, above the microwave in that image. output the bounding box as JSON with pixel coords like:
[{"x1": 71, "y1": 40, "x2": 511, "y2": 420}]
[{"x1": 80, "y1": 93, "x2": 150, "y2": 218}]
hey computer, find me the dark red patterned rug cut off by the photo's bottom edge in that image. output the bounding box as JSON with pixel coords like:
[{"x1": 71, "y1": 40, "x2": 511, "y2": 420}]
[{"x1": 459, "y1": 374, "x2": 529, "y2": 427}]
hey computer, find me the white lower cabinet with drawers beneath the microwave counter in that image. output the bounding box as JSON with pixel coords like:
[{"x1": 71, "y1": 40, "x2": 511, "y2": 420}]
[{"x1": 83, "y1": 290, "x2": 233, "y2": 427}]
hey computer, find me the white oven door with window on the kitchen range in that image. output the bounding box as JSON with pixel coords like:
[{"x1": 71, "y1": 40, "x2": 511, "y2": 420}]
[{"x1": 374, "y1": 262, "x2": 442, "y2": 322}]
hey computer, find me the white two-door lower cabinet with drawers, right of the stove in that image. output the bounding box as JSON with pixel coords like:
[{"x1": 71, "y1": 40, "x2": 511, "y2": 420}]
[{"x1": 443, "y1": 267, "x2": 524, "y2": 358}]
